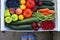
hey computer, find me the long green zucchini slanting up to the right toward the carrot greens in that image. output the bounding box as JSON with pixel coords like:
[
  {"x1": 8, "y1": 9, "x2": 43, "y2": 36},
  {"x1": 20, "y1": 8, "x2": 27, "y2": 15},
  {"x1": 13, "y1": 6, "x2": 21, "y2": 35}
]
[{"x1": 11, "y1": 17, "x2": 39, "y2": 25}]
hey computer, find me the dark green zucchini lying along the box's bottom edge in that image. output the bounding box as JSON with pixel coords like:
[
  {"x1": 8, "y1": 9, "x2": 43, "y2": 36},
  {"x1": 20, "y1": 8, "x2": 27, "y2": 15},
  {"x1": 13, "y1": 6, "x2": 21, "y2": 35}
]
[{"x1": 6, "y1": 24, "x2": 32, "y2": 30}]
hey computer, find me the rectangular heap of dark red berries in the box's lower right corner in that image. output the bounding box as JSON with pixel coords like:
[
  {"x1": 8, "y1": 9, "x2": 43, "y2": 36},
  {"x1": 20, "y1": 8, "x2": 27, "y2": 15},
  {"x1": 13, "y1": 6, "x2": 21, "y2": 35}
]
[{"x1": 41, "y1": 21, "x2": 55, "y2": 30}]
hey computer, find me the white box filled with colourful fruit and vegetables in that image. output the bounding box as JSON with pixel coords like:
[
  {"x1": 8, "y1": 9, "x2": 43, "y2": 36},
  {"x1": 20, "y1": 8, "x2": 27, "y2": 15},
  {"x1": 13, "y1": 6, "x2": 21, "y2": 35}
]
[{"x1": 1, "y1": 0, "x2": 58, "y2": 32}]
